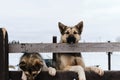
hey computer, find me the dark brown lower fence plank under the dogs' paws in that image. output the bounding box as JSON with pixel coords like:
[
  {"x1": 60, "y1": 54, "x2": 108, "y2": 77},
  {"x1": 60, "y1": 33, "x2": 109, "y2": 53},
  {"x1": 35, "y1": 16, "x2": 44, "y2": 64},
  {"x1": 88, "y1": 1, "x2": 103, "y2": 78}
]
[{"x1": 9, "y1": 71, "x2": 120, "y2": 80}]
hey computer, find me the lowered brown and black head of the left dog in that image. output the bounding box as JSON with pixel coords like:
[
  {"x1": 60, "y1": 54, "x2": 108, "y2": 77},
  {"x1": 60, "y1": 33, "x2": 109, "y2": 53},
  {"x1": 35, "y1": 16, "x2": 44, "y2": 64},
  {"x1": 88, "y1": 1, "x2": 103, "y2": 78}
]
[{"x1": 19, "y1": 53, "x2": 43, "y2": 80}]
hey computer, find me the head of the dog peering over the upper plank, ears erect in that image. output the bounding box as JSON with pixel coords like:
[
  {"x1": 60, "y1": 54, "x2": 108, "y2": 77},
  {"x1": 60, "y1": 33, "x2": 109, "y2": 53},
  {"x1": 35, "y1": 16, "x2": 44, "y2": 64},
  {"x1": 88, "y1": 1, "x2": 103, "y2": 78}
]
[{"x1": 58, "y1": 21, "x2": 83, "y2": 44}]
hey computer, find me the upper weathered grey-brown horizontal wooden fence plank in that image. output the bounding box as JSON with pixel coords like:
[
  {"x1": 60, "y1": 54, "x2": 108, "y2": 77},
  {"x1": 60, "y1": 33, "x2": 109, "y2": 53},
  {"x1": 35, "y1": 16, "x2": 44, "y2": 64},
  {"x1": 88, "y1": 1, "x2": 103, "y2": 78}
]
[{"x1": 9, "y1": 42, "x2": 120, "y2": 53}]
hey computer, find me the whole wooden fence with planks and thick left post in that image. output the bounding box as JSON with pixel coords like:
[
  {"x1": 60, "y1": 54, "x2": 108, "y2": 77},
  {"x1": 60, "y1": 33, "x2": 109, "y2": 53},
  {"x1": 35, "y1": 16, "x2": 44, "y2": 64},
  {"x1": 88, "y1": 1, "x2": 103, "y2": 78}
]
[{"x1": 0, "y1": 28, "x2": 120, "y2": 80}]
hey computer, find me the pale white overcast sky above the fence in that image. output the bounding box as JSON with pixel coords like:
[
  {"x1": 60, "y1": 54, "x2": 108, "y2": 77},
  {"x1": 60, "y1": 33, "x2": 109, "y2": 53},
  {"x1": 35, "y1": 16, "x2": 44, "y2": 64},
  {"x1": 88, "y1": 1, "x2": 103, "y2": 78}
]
[{"x1": 0, "y1": 0, "x2": 120, "y2": 42}]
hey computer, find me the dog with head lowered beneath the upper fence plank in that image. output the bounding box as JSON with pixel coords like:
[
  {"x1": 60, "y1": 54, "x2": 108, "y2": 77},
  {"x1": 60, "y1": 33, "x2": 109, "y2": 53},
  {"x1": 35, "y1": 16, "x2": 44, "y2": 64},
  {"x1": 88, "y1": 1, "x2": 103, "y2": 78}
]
[{"x1": 19, "y1": 52, "x2": 56, "y2": 80}]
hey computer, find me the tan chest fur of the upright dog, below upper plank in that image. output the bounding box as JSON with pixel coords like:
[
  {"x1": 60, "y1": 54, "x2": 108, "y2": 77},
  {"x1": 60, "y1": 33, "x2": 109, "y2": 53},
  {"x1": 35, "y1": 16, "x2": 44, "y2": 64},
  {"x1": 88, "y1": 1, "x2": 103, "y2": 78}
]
[{"x1": 54, "y1": 53, "x2": 82, "y2": 70}]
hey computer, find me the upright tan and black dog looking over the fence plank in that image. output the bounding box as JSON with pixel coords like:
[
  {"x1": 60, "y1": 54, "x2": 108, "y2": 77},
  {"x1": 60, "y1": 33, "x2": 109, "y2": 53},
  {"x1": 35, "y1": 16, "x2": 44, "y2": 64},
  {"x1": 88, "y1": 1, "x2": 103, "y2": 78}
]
[{"x1": 53, "y1": 21, "x2": 104, "y2": 80}]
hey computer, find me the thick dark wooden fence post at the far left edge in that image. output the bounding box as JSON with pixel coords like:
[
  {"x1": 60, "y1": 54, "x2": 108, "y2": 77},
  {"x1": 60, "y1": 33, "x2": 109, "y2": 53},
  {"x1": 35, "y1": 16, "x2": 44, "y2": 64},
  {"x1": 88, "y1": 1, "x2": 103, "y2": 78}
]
[{"x1": 0, "y1": 28, "x2": 9, "y2": 80}]
